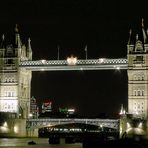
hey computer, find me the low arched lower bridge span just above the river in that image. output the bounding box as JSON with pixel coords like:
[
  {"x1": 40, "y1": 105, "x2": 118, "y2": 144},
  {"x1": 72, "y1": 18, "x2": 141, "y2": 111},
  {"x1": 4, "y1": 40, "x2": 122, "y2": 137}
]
[{"x1": 26, "y1": 118, "x2": 119, "y2": 130}]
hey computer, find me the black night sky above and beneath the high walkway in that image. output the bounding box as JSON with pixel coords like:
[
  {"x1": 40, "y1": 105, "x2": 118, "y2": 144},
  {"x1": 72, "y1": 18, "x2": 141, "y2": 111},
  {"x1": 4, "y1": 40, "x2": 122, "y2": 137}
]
[{"x1": 0, "y1": 0, "x2": 148, "y2": 117}]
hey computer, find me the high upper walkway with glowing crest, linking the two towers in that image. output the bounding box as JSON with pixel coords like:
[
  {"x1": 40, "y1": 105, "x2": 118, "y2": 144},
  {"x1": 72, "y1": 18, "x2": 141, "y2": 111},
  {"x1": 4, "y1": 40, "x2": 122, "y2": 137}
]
[{"x1": 19, "y1": 58, "x2": 128, "y2": 71}]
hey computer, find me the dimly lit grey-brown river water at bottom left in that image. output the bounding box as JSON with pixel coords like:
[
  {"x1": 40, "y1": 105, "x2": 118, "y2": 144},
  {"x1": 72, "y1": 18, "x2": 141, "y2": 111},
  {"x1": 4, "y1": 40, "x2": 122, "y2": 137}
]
[{"x1": 0, "y1": 138, "x2": 82, "y2": 148}]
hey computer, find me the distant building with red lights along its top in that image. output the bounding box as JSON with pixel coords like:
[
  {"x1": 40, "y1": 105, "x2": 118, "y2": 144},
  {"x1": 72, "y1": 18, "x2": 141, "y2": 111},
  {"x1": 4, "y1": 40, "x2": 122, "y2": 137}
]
[{"x1": 42, "y1": 100, "x2": 52, "y2": 113}]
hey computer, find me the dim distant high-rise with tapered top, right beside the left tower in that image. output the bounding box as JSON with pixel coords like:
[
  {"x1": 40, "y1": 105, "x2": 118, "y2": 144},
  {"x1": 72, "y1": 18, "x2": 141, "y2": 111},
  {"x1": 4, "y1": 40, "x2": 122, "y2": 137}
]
[{"x1": 30, "y1": 97, "x2": 39, "y2": 118}]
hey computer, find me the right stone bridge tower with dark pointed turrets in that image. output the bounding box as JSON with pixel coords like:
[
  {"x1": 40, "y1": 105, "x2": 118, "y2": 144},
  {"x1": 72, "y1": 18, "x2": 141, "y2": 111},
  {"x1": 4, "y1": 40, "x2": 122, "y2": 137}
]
[{"x1": 127, "y1": 19, "x2": 148, "y2": 119}]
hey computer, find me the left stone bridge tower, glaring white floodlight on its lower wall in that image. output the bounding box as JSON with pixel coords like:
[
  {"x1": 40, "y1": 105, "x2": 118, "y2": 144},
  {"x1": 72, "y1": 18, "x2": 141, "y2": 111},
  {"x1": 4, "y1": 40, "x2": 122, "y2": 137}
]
[{"x1": 0, "y1": 25, "x2": 32, "y2": 136}]
